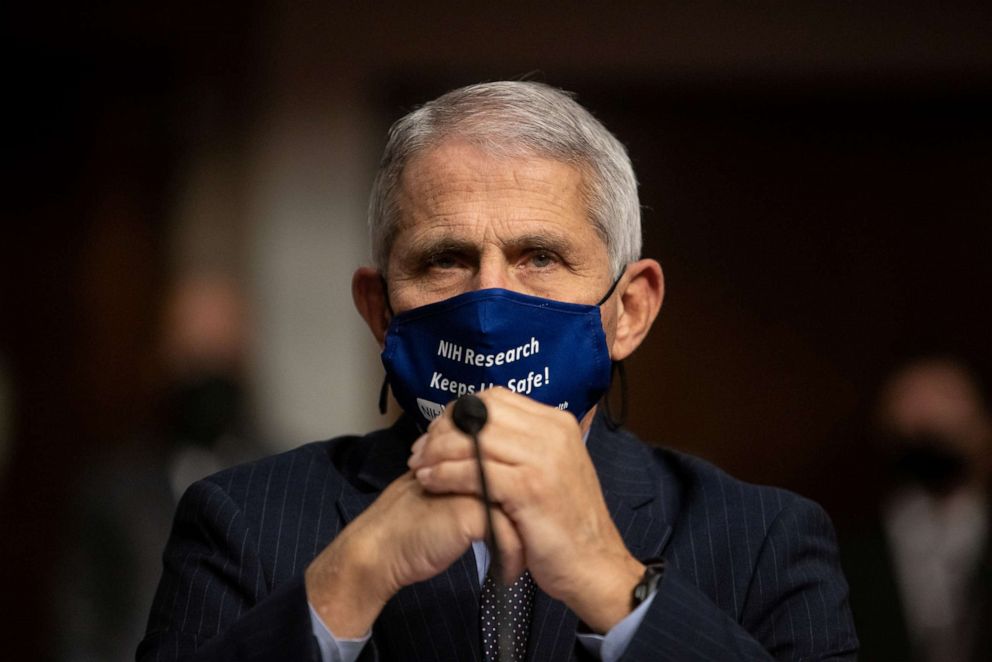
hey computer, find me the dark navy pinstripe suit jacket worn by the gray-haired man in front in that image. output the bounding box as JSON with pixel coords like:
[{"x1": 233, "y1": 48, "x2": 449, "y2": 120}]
[{"x1": 138, "y1": 418, "x2": 857, "y2": 662}]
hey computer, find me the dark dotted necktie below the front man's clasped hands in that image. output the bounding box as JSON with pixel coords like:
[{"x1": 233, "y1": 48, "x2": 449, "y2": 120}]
[{"x1": 480, "y1": 571, "x2": 537, "y2": 662}]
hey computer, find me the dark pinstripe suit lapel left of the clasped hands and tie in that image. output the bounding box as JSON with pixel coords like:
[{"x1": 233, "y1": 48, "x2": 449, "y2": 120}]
[{"x1": 337, "y1": 418, "x2": 481, "y2": 661}]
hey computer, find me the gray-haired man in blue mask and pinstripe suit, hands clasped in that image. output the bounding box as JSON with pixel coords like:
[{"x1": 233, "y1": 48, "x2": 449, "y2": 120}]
[{"x1": 138, "y1": 82, "x2": 857, "y2": 661}]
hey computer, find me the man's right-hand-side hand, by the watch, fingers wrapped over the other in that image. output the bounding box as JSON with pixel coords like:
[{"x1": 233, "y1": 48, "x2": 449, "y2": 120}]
[{"x1": 408, "y1": 388, "x2": 643, "y2": 631}]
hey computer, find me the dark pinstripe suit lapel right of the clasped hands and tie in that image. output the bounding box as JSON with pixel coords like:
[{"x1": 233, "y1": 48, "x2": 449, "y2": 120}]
[{"x1": 527, "y1": 416, "x2": 679, "y2": 662}]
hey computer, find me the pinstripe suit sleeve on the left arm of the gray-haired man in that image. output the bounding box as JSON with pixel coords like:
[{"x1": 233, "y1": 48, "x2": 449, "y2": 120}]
[{"x1": 137, "y1": 481, "x2": 320, "y2": 662}]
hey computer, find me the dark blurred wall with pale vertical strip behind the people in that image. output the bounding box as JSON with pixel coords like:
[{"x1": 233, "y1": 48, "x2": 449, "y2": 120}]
[{"x1": 0, "y1": 0, "x2": 992, "y2": 660}]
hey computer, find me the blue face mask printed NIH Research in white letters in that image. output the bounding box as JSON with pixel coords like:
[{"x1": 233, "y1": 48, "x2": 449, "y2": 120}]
[{"x1": 382, "y1": 282, "x2": 616, "y2": 426}]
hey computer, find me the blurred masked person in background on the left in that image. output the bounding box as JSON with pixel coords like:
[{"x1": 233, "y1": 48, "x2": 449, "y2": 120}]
[{"x1": 58, "y1": 273, "x2": 260, "y2": 662}]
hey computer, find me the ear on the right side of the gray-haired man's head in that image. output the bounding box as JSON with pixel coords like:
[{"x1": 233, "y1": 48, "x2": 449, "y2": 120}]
[{"x1": 610, "y1": 260, "x2": 665, "y2": 361}]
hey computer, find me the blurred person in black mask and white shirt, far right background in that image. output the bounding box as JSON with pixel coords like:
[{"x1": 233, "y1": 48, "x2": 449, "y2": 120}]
[{"x1": 841, "y1": 357, "x2": 992, "y2": 662}]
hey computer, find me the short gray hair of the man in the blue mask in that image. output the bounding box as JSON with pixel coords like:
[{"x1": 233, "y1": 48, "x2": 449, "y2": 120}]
[{"x1": 368, "y1": 81, "x2": 641, "y2": 275}]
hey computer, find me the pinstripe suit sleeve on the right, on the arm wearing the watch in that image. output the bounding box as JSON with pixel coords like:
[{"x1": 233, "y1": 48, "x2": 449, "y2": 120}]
[{"x1": 621, "y1": 498, "x2": 858, "y2": 662}]
